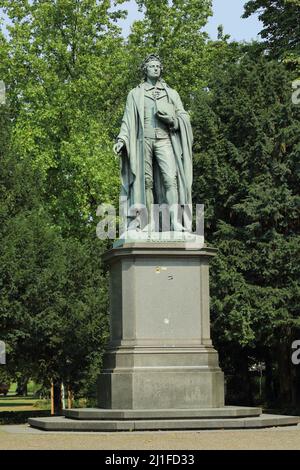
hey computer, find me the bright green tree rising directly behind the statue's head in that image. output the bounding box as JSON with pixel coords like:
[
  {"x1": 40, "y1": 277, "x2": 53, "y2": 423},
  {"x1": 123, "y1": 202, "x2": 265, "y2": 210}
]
[{"x1": 128, "y1": 0, "x2": 212, "y2": 105}]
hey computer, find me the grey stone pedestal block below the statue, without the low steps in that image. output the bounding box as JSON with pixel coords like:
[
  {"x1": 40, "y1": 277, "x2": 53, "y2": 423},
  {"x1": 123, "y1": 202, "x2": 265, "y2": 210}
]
[{"x1": 98, "y1": 242, "x2": 224, "y2": 410}]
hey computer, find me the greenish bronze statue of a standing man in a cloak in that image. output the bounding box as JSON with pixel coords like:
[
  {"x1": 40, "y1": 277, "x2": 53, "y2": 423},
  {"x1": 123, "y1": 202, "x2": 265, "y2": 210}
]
[{"x1": 114, "y1": 54, "x2": 193, "y2": 231}]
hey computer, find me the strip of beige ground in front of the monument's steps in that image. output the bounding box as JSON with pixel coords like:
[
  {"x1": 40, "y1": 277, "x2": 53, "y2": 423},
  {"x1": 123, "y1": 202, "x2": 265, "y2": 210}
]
[{"x1": 0, "y1": 425, "x2": 300, "y2": 450}]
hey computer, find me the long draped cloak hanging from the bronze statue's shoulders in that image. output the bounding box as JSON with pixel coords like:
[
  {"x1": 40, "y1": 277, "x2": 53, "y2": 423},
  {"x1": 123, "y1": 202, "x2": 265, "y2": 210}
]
[{"x1": 118, "y1": 82, "x2": 193, "y2": 224}]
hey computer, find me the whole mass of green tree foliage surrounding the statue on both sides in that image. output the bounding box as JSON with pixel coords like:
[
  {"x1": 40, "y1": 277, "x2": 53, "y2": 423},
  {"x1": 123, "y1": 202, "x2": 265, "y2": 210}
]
[{"x1": 0, "y1": 0, "x2": 300, "y2": 406}]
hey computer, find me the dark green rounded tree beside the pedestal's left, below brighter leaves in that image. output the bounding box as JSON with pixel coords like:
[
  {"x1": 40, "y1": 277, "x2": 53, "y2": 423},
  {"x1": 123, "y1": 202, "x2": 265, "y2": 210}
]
[{"x1": 0, "y1": 202, "x2": 107, "y2": 390}]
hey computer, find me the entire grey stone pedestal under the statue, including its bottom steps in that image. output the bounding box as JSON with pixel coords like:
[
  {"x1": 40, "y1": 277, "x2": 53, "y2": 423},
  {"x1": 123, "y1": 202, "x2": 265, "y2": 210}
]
[{"x1": 28, "y1": 241, "x2": 299, "y2": 432}]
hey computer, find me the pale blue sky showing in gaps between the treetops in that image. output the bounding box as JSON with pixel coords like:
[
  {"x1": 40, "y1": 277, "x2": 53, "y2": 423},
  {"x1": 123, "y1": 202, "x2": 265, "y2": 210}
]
[{"x1": 121, "y1": 0, "x2": 262, "y2": 41}]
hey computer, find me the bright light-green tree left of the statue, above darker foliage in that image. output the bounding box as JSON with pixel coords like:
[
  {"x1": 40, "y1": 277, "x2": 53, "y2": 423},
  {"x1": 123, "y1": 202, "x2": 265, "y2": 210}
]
[{"x1": 0, "y1": 0, "x2": 126, "y2": 236}]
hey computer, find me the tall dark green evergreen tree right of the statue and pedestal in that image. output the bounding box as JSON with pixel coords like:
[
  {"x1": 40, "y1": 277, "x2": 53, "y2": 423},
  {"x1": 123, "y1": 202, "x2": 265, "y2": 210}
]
[{"x1": 193, "y1": 46, "x2": 300, "y2": 403}]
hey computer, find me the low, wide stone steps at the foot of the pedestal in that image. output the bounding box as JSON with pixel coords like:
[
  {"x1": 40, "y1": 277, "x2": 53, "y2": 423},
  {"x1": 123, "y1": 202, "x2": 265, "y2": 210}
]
[{"x1": 28, "y1": 407, "x2": 300, "y2": 432}]
